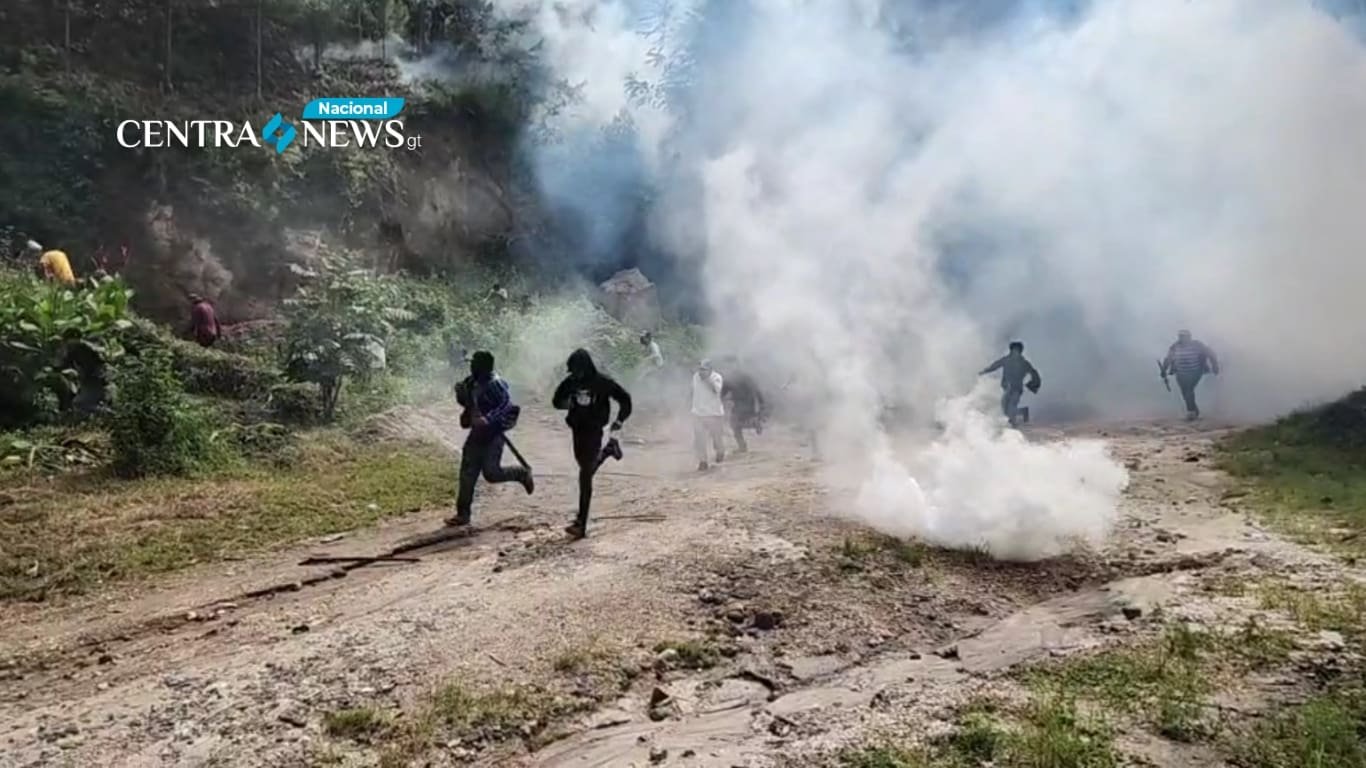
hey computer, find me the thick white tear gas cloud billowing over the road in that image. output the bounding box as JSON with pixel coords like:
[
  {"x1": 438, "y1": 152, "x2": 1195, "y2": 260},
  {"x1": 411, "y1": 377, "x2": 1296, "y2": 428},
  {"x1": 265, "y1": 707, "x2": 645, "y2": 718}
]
[{"x1": 507, "y1": 0, "x2": 1366, "y2": 559}]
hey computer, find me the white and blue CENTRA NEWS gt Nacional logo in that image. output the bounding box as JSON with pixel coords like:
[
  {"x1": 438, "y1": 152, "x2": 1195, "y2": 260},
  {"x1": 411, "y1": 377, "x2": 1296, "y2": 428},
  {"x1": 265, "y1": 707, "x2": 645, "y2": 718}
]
[{"x1": 117, "y1": 98, "x2": 422, "y2": 154}]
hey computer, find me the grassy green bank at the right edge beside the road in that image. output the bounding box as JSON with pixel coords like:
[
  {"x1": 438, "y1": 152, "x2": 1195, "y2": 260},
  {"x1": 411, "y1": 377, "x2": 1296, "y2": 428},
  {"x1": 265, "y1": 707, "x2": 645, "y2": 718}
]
[{"x1": 1221, "y1": 389, "x2": 1366, "y2": 553}]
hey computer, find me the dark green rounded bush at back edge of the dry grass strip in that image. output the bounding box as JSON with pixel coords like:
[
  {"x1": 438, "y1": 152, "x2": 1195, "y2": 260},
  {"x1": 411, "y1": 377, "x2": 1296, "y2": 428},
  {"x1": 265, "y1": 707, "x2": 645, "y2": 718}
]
[{"x1": 109, "y1": 347, "x2": 232, "y2": 477}]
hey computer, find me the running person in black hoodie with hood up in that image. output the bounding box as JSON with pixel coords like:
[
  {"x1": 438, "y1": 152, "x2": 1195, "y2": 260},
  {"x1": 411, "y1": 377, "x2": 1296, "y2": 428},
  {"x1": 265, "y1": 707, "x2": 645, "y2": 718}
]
[{"x1": 552, "y1": 350, "x2": 631, "y2": 538}]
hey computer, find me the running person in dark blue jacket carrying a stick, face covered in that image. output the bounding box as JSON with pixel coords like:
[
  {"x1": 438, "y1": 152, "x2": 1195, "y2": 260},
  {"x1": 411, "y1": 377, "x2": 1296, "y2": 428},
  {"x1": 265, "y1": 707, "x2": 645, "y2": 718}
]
[{"x1": 445, "y1": 350, "x2": 535, "y2": 526}]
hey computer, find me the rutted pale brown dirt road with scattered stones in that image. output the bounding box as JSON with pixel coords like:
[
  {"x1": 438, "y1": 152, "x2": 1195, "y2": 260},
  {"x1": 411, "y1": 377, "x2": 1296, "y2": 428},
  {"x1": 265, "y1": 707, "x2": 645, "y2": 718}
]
[{"x1": 0, "y1": 413, "x2": 1336, "y2": 767}]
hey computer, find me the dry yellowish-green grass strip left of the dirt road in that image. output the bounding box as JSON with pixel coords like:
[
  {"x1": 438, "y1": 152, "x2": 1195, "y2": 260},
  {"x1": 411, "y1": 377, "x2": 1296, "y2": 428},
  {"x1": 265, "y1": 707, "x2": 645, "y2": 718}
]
[{"x1": 0, "y1": 433, "x2": 455, "y2": 600}]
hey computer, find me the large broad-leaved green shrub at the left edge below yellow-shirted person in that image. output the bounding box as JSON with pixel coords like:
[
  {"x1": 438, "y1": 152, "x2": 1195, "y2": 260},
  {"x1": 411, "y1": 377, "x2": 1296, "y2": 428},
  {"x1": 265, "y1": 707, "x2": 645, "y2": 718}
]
[{"x1": 0, "y1": 267, "x2": 133, "y2": 426}]
